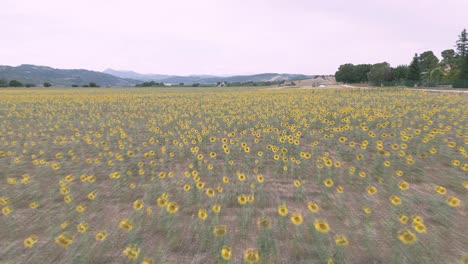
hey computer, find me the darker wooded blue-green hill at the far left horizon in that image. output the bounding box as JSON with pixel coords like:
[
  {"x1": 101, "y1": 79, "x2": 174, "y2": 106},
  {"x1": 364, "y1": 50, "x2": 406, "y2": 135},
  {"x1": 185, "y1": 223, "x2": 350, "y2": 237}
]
[{"x1": 0, "y1": 64, "x2": 141, "y2": 87}]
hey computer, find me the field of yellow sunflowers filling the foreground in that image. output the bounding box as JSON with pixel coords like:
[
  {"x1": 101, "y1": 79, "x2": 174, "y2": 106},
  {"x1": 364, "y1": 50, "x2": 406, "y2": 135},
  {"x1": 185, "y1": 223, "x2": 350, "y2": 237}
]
[{"x1": 0, "y1": 88, "x2": 468, "y2": 264}]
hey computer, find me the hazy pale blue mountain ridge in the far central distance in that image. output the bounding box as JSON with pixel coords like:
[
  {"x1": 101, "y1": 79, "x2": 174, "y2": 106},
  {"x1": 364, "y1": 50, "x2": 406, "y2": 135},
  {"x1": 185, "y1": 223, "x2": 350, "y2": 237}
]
[{"x1": 104, "y1": 69, "x2": 314, "y2": 84}]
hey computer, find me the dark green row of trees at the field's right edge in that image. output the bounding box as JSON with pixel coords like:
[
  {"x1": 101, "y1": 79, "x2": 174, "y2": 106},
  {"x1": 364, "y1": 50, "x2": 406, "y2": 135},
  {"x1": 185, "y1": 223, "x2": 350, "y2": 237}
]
[{"x1": 335, "y1": 29, "x2": 468, "y2": 88}]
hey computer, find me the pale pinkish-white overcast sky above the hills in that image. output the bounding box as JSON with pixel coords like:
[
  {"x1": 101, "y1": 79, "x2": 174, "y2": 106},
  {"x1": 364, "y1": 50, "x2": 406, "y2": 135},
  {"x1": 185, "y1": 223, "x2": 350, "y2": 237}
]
[{"x1": 0, "y1": 0, "x2": 468, "y2": 75}]
